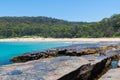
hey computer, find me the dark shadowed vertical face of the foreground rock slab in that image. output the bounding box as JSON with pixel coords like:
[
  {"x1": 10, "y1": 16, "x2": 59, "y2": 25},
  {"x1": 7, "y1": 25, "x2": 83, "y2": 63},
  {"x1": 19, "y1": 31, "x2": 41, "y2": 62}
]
[{"x1": 58, "y1": 55, "x2": 119, "y2": 80}]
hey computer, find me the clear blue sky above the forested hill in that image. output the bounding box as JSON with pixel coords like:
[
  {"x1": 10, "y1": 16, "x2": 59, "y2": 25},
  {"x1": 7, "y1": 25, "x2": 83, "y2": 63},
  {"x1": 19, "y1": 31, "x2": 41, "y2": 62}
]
[{"x1": 0, "y1": 0, "x2": 120, "y2": 22}]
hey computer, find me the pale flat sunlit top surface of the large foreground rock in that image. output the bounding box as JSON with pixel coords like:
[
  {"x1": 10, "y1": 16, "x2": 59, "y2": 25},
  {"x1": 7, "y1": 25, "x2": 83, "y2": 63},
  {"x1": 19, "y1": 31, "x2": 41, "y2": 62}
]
[{"x1": 0, "y1": 56, "x2": 104, "y2": 80}]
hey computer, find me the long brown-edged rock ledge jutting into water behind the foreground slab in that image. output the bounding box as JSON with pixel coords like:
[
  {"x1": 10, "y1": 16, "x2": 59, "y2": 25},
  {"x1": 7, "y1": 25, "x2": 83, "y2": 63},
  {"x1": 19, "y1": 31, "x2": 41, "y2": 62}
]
[{"x1": 10, "y1": 45, "x2": 120, "y2": 62}]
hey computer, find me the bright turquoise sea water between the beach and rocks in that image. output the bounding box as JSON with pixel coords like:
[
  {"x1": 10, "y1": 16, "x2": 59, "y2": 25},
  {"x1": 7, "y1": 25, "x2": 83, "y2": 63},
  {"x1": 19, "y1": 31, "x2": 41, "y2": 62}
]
[{"x1": 0, "y1": 42, "x2": 71, "y2": 65}]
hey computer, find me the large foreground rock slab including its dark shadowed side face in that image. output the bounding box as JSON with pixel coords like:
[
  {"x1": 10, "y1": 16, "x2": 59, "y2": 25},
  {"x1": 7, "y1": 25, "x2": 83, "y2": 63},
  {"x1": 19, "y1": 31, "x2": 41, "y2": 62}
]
[{"x1": 0, "y1": 55, "x2": 117, "y2": 80}]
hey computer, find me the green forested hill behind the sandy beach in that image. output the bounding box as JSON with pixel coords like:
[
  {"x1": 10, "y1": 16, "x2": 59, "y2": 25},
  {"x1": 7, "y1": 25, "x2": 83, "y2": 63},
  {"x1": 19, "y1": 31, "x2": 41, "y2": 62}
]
[{"x1": 0, "y1": 14, "x2": 120, "y2": 38}]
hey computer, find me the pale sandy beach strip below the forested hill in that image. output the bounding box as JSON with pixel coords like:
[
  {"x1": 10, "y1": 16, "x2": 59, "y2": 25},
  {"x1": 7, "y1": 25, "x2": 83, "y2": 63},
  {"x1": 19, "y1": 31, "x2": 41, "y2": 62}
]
[{"x1": 0, "y1": 38, "x2": 120, "y2": 42}]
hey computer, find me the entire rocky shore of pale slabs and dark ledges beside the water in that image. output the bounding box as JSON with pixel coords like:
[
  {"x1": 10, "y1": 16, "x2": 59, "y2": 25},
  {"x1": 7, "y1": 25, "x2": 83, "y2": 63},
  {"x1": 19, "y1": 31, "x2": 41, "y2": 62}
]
[{"x1": 0, "y1": 42, "x2": 120, "y2": 80}]
